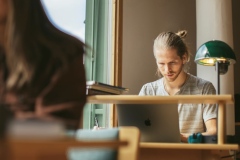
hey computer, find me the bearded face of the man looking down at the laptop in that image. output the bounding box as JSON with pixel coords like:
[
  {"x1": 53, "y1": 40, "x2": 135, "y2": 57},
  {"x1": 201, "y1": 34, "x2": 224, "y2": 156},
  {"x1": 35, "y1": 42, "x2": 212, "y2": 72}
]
[{"x1": 155, "y1": 49, "x2": 186, "y2": 82}]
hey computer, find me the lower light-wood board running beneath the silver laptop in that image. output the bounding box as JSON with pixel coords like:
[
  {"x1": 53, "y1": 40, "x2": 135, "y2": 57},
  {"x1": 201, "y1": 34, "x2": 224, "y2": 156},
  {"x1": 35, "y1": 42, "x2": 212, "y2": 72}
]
[{"x1": 140, "y1": 142, "x2": 239, "y2": 150}]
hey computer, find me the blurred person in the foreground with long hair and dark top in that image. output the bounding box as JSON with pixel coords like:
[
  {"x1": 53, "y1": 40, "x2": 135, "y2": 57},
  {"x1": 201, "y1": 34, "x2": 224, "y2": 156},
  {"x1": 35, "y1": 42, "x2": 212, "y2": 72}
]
[{"x1": 0, "y1": 0, "x2": 86, "y2": 129}]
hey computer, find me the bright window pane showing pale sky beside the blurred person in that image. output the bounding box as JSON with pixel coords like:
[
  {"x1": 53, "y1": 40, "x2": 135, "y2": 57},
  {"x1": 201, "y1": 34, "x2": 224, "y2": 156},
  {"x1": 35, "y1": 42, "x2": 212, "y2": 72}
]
[{"x1": 42, "y1": 0, "x2": 86, "y2": 42}]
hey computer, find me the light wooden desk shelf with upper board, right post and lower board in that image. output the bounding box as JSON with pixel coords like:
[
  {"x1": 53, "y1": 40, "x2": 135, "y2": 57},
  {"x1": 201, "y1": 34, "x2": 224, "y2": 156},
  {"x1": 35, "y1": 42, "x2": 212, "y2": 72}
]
[{"x1": 87, "y1": 94, "x2": 236, "y2": 150}]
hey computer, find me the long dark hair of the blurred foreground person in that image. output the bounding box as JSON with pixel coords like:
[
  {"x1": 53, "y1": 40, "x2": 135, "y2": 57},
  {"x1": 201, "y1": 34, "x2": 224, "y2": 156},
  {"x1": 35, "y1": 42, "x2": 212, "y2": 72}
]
[{"x1": 4, "y1": 0, "x2": 84, "y2": 96}]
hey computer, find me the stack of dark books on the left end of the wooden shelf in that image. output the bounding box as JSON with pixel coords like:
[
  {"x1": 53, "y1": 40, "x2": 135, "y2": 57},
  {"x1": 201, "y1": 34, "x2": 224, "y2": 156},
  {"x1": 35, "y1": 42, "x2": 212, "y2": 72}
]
[{"x1": 86, "y1": 81, "x2": 128, "y2": 95}]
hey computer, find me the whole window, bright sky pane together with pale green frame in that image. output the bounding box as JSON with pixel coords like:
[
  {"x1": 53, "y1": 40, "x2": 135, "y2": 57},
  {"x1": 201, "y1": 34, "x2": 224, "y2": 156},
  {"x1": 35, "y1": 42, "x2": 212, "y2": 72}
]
[{"x1": 43, "y1": 0, "x2": 123, "y2": 128}]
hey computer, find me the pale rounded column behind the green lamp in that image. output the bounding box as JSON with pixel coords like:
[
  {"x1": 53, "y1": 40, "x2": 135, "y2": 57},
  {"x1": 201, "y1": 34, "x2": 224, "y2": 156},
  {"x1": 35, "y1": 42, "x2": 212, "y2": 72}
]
[{"x1": 196, "y1": 0, "x2": 235, "y2": 135}]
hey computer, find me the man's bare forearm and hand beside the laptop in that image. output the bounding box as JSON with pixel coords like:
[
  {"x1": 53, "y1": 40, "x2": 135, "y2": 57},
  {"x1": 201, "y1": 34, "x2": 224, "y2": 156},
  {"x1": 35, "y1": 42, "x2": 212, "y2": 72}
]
[{"x1": 181, "y1": 118, "x2": 217, "y2": 143}]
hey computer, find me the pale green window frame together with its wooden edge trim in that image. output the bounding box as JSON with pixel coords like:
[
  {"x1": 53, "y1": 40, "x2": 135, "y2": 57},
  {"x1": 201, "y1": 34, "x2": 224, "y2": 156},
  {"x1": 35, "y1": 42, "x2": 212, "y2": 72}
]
[{"x1": 82, "y1": 0, "x2": 122, "y2": 128}]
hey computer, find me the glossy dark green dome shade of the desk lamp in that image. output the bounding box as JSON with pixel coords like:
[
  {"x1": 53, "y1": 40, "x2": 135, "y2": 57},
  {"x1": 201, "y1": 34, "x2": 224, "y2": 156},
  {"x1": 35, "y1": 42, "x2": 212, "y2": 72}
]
[{"x1": 194, "y1": 40, "x2": 236, "y2": 66}]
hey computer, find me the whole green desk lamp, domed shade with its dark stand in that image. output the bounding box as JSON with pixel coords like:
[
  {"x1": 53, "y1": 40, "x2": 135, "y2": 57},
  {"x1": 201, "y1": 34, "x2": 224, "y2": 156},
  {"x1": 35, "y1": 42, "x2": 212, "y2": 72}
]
[{"x1": 194, "y1": 40, "x2": 236, "y2": 94}]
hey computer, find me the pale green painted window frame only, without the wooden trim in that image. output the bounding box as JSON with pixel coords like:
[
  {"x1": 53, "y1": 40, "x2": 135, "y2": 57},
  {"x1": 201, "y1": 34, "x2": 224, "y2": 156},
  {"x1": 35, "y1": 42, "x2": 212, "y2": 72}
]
[{"x1": 83, "y1": 0, "x2": 111, "y2": 128}]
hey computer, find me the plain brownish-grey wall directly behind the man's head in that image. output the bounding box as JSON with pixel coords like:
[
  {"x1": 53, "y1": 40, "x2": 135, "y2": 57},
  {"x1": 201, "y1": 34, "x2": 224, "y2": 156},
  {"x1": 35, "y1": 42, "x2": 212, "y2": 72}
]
[{"x1": 122, "y1": 0, "x2": 196, "y2": 94}]
